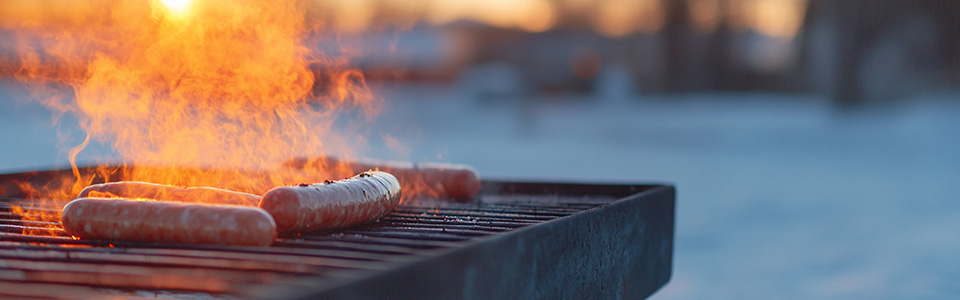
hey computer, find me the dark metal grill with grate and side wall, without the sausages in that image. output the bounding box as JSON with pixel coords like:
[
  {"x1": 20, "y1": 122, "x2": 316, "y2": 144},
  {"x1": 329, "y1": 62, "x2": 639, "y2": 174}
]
[{"x1": 0, "y1": 169, "x2": 675, "y2": 299}]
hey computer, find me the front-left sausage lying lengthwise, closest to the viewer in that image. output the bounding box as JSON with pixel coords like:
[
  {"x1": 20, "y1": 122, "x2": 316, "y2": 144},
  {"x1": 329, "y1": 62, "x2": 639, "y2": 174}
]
[{"x1": 62, "y1": 198, "x2": 277, "y2": 246}]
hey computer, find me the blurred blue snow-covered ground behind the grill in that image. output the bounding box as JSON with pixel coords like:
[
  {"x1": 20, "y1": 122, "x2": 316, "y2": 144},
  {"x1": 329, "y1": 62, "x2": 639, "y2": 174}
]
[{"x1": 0, "y1": 80, "x2": 960, "y2": 299}]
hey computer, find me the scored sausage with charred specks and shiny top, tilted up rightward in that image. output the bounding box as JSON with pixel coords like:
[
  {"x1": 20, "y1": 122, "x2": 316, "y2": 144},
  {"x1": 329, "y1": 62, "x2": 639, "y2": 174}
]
[{"x1": 260, "y1": 171, "x2": 400, "y2": 233}]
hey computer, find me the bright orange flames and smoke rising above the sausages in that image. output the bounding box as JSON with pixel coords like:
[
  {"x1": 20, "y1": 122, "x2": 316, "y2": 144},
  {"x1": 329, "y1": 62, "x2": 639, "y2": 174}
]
[{"x1": 0, "y1": 0, "x2": 377, "y2": 231}]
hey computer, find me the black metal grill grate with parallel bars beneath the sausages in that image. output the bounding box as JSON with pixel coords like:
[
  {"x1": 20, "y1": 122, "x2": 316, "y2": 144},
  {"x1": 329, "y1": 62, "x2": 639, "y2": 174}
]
[{"x1": 0, "y1": 170, "x2": 673, "y2": 299}]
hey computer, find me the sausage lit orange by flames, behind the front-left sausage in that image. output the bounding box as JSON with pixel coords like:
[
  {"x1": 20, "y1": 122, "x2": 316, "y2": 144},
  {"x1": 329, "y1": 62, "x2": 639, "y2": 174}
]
[{"x1": 77, "y1": 181, "x2": 261, "y2": 207}]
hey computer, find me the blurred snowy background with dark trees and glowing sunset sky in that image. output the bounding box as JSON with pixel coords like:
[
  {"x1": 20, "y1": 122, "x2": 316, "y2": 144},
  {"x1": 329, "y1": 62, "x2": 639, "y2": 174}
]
[{"x1": 0, "y1": 0, "x2": 960, "y2": 299}]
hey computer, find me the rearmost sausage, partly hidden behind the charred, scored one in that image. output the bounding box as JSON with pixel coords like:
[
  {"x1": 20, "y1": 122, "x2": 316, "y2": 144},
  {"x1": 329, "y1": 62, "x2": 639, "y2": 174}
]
[{"x1": 283, "y1": 157, "x2": 481, "y2": 200}]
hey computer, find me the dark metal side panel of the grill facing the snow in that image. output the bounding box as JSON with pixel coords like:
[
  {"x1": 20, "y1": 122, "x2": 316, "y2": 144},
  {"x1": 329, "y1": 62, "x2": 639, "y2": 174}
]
[{"x1": 273, "y1": 186, "x2": 675, "y2": 299}]
